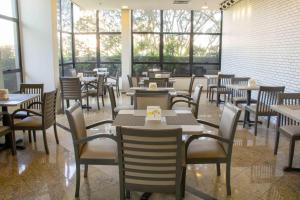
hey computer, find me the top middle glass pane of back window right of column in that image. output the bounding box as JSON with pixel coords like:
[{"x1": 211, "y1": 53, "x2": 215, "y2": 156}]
[{"x1": 163, "y1": 10, "x2": 191, "y2": 33}]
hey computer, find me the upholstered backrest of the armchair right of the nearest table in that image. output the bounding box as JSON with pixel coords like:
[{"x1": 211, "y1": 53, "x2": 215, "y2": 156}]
[{"x1": 219, "y1": 103, "x2": 241, "y2": 156}]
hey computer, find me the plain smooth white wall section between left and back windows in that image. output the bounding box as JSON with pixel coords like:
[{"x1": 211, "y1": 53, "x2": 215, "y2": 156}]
[{"x1": 19, "y1": 0, "x2": 59, "y2": 91}]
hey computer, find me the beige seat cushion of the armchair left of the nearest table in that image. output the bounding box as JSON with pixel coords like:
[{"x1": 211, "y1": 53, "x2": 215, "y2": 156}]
[{"x1": 80, "y1": 138, "x2": 118, "y2": 162}]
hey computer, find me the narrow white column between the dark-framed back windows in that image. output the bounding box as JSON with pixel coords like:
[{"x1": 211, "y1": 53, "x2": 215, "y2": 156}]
[{"x1": 121, "y1": 9, "x2": 131, "y2": 90}]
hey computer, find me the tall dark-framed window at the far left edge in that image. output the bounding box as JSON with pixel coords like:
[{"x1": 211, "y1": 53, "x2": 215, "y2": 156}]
[{"x1": 0, "y1": 0, "x2": 22, "y2": 92}]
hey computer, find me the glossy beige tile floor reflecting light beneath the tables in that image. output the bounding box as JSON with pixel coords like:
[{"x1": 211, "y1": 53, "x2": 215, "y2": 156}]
[{"x1": 0, "y1": 95, "x2": 300, "y2": 200}]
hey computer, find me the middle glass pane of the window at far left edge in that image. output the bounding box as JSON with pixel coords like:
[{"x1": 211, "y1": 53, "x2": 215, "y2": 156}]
[{"x1": 0, "y1": 19, "x2": 19, "y2": 71}]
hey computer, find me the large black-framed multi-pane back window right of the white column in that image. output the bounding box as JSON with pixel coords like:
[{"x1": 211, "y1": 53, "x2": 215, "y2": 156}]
[{"x1": 132, "y1": 10, "x2": 222, "y2": 76}]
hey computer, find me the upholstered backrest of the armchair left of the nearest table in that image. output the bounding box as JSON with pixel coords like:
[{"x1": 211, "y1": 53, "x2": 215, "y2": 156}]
[{"x1": 66, "y1": 102, "x2": 87, "y2": 158}]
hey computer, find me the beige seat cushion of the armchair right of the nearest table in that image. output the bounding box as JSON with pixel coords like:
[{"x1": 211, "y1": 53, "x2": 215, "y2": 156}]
[{"x1": 187, "y1": 139, "x2": 226, "y2": 163}]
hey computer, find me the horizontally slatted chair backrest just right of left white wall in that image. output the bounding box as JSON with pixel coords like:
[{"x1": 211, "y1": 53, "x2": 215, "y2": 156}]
[{"x1": 60, "y1": 77, "x2": 81, "y2": 101}]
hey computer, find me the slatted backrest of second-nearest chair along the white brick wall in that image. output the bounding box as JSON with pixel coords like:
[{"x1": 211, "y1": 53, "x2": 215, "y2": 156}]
[{"x1": 256, "y1": 86, "x2": 285, "y2": 115}]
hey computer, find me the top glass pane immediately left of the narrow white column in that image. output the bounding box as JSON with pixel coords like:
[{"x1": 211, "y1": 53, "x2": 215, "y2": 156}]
[{"x1": 99, "y1": 10, "x2": 121, "y2": 32}]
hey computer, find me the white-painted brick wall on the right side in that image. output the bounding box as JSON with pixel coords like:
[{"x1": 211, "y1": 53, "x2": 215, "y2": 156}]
[{"x1": 222, "y1": 0, "x2": 300, "y2": 92}]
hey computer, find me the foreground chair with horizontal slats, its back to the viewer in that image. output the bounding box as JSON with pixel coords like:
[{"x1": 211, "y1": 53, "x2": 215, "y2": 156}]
[{"x1": 117, "y1": 127, "x2": 184, "y2": 200}]
